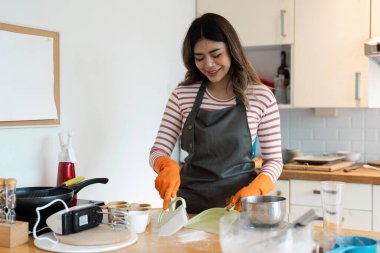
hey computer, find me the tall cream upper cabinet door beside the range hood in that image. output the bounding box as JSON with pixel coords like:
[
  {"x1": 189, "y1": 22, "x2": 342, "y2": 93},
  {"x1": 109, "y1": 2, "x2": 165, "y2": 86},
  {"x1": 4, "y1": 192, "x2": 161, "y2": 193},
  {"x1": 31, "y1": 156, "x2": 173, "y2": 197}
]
[{"x1": 293, "y1": 0, "x2": 370, "y2": 107}]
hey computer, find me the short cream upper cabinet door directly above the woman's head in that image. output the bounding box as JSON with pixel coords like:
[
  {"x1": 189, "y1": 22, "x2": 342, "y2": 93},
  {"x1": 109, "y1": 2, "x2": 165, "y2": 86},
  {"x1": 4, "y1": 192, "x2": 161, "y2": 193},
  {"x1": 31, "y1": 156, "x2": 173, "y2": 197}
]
[{"x1": 197, "y1": 0, "x2": 294, "y2": 46}]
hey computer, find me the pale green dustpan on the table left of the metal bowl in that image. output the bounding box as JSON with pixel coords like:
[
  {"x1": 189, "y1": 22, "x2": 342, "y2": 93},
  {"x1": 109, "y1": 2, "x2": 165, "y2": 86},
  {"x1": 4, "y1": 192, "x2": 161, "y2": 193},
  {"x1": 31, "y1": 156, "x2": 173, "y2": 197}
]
[{"x1": 185, "y1": 208, "x2": 240, "y2": 234}]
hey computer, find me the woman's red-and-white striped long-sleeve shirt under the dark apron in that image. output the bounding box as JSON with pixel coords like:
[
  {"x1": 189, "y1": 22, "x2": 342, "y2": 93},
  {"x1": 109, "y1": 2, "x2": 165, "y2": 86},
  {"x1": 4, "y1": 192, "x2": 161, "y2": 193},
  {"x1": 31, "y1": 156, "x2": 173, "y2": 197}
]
[{"x1": 149, "y1": 83, "x2": 283, "y2": 182}]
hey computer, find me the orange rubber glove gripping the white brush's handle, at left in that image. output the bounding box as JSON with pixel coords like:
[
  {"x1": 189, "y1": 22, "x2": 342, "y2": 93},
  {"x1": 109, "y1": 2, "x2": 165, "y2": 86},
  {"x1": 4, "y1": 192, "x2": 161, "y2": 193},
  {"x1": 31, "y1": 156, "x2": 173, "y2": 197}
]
[{"x1": 153, "y1": 156, "x2": 181, "y2": 210}]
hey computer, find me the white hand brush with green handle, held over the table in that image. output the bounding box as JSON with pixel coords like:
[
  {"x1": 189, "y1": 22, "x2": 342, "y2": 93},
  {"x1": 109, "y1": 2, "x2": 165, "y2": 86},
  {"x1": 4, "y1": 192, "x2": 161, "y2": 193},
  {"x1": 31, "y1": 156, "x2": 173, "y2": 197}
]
[{"x1": 158, "y1": 197, "x2": 189, "y2": 236}]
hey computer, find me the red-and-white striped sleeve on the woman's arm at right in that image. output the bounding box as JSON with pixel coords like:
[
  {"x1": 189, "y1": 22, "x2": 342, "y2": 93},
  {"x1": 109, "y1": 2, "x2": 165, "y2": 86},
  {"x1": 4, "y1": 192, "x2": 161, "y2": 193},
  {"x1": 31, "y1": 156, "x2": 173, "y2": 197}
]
[{"x1": 251, "y1": 85, "x2": 283, "y2": 182}]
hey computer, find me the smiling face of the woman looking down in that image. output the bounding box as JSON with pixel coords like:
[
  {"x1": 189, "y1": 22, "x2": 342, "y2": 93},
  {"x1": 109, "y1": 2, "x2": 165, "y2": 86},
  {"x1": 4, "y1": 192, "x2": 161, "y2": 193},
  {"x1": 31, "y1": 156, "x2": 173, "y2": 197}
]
[{"x1": 194, "y1": 39, "x2": 231, "y2": 85}]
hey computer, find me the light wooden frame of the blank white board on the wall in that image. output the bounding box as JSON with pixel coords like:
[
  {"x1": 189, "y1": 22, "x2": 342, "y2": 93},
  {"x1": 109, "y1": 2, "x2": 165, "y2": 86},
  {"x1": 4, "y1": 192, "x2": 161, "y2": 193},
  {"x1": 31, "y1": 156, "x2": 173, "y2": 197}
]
[{"x1": 0, "y1": 23, "x2": 60, "y2": 127}]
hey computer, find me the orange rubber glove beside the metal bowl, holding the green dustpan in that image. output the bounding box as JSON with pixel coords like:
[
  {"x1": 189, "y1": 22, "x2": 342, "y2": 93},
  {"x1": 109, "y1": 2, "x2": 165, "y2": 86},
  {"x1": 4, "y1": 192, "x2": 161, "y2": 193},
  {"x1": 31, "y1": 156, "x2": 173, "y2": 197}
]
[{"x1": 227, "y1": 174, "x2": 274, "y2": 212}]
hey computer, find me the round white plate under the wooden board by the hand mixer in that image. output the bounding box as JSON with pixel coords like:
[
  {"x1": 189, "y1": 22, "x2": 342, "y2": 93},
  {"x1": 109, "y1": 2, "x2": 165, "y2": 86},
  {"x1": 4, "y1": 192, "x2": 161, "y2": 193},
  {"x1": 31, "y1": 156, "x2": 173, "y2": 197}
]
[{"x1": 34, "y1": 232, "x2": 138, "y2": 253}]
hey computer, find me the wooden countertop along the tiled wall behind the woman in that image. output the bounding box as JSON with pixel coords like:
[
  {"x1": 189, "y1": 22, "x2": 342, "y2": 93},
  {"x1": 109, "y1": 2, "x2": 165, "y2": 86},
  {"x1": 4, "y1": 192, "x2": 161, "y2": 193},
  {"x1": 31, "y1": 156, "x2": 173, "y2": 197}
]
[{"x1": 280, "y1": 168, "x2": 380, "y2": 185}]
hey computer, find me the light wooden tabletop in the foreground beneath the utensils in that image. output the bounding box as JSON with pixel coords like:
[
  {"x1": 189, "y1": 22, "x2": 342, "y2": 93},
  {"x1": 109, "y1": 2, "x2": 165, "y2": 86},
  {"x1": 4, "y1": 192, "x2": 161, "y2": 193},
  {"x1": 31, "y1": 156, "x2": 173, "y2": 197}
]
[{"x1": 0, "y1": 227, "x2": 380, "y2": 253}]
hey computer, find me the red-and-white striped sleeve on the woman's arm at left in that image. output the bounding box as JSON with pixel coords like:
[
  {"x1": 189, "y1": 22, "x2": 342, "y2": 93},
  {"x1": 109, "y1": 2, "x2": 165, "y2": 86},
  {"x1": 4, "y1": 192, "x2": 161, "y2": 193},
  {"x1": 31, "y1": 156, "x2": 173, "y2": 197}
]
[{"x1": 149, "y1": 90, "x2": 182, "y2": 168}]
